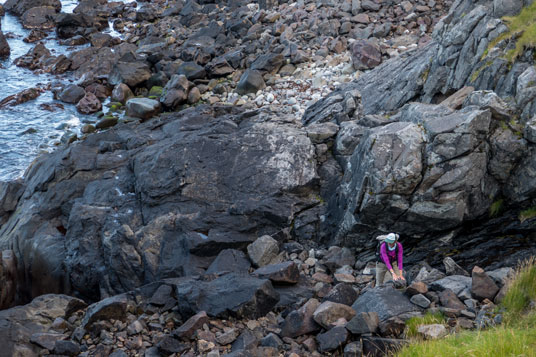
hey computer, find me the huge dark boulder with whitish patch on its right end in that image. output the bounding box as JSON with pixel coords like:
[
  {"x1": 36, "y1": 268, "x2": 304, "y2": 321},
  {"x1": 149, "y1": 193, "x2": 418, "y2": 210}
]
[{"x1": 0, "y1": 106, "x2": 319, "y2": 300}]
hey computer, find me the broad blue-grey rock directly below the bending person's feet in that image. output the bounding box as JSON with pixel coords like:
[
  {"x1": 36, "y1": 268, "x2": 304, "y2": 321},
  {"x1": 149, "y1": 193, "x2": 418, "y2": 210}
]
[{"x1": 352, "y1": 286, "x2": 419, "y2": 322}]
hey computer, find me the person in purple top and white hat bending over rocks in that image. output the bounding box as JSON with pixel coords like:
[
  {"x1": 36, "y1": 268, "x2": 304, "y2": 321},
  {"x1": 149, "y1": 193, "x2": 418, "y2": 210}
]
[{"x1": 376, "y1": 233, "x2": 406, "y2": 286}]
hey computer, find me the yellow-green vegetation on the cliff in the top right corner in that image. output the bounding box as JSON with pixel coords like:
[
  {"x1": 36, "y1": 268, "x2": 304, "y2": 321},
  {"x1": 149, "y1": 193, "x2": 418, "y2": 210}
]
[{"x1": 484, "y1": 2, "x2": 536, "y2": 63}]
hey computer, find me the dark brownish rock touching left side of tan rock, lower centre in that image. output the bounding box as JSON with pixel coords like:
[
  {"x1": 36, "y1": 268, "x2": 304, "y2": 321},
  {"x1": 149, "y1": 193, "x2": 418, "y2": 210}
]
[{"x1": 281, "y1": 299, "x2": 321, "y2": 338}]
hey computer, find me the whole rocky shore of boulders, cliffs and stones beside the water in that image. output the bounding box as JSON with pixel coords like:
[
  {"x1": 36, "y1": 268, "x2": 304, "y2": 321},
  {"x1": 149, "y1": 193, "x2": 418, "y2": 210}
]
[{"x1": 0, "y1": 0, "x2": 536, "y2": 357}]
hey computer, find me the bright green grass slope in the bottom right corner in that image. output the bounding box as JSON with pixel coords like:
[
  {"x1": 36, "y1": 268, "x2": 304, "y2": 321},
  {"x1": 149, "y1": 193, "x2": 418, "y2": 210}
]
[{"x1": 396, "y1": 257, "x2": 536, "y2": 357}]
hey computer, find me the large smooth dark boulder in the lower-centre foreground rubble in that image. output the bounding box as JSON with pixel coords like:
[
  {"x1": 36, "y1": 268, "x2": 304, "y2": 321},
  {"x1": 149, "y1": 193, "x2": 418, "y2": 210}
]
[{"x1": 176, "y1": 273, "x2": 279, "y2": 318}]
